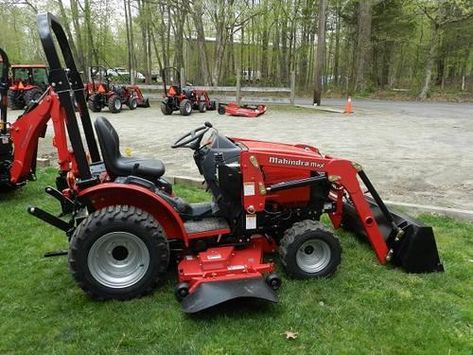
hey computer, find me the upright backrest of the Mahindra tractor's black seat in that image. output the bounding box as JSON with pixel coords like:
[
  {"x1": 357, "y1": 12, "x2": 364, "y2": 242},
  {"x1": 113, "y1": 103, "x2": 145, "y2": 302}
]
[{"x1": 94, "y1": 117, "x2": 122, "y2": 176}]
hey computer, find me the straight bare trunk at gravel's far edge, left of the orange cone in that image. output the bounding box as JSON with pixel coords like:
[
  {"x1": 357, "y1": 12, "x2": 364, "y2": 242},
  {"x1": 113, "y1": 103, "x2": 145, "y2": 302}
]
[{"x1": 313, "y1": 0, "x2": 327, "y2": 106}]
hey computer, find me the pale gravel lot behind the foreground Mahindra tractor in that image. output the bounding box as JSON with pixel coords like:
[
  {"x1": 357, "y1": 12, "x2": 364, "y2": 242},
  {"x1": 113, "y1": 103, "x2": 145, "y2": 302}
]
[{"x1": 36, "y1": 100, "x2": 473, "y2": 210}]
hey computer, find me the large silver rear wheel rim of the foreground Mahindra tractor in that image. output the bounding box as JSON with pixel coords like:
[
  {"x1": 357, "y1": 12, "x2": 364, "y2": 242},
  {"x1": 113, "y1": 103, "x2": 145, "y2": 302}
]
[{"x1": 87, "y1": 232, "x2": 150, "y2": 288}]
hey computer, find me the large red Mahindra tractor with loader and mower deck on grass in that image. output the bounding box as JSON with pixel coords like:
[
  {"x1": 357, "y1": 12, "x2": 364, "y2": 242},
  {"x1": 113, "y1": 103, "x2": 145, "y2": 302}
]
[{"x1": 17, "y1": 14, "x2": 443, "y2": 313}]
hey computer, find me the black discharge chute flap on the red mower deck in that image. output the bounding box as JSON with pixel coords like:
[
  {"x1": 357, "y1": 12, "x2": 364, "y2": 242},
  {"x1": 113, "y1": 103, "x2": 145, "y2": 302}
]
[{"x1": 182, "y1": 277, "x2": 278, "y2": 313}]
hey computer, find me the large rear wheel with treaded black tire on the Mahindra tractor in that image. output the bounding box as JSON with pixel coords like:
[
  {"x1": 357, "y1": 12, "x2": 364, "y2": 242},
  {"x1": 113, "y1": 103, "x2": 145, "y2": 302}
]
[{"x1": 69, "y1": 205, "x2": 169, "y2": 300}]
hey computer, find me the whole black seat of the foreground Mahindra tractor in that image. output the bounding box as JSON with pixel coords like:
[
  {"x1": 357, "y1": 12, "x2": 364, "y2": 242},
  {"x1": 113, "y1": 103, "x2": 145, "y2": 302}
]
[{"x1": 94, "y1": 117, "x2": 165, "y2": 181}]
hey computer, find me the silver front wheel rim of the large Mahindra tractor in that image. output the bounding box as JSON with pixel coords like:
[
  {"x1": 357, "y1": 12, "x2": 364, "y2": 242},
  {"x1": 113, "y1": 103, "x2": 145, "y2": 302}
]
[{"x1": 296, "y1": 239, "x2": 332, "y2": 274}]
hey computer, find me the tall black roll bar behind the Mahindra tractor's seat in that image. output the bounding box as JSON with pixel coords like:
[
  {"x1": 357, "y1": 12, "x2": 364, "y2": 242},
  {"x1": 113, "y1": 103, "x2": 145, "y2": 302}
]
[{"x1": 36, "y1": 12, "x2": 101, "y2": 182}]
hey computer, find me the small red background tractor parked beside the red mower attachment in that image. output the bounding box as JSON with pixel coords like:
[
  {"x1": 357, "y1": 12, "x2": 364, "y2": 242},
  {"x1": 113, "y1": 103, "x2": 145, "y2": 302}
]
[{"x1": 161, "y1": 67, "x2": 217, "y2": 116}]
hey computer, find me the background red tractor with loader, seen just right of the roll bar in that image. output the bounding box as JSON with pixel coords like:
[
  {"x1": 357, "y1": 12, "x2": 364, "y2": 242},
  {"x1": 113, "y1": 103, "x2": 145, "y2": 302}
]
[{"x1": 85, "y1": 65, "x2": 149, "y2": 113}]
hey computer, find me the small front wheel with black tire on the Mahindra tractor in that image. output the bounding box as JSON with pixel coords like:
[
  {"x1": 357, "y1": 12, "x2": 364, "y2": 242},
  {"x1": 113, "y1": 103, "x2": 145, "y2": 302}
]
[{"x1": 279, "y1": 220, "x2": 342, "y2": 279}]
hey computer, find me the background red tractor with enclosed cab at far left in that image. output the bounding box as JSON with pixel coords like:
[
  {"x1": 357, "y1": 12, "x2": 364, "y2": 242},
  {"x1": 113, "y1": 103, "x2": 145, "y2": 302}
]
[{"x1": 8, "y1": 64, "x2": 48, "y2": 110}]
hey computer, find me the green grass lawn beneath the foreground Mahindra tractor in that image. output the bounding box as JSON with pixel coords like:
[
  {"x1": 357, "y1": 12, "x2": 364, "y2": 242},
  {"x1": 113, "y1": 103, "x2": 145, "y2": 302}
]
[{"x1": 0, "y1": 170, "x2": 473, "y2": 355}]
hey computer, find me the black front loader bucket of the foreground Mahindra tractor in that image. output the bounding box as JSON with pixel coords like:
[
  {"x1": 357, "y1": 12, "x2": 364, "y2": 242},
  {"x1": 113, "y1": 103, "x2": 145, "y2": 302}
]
[{"x1": 342, "y1": 196, "x2": 444, "y2": 273}]
